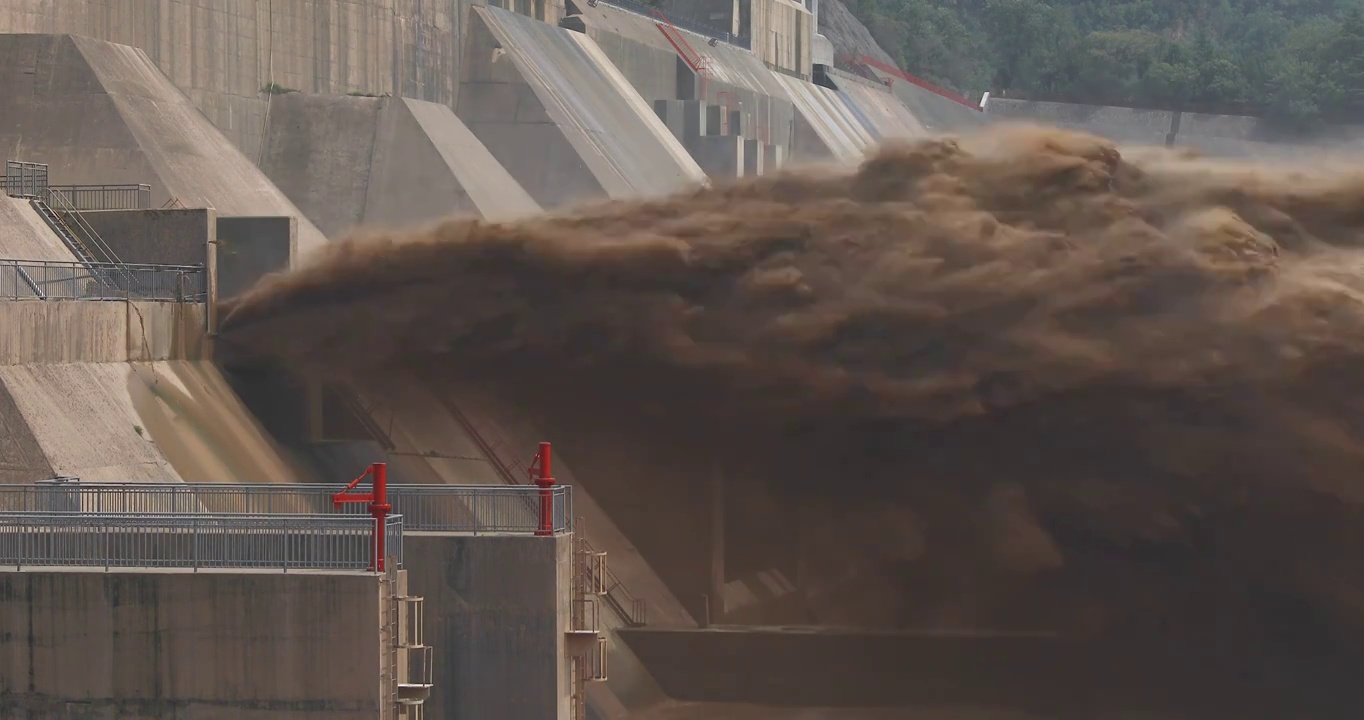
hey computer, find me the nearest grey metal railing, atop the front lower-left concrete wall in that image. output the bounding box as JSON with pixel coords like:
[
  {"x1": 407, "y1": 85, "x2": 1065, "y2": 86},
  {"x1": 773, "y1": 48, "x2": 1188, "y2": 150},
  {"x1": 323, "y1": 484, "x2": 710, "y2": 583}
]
[{"x1": 0, "y1": 513, "x2": 402, "y2": 571}]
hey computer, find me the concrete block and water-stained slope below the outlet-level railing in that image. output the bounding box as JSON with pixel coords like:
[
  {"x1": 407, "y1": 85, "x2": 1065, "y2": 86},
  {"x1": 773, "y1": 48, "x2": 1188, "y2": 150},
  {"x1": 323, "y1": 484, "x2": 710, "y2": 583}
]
[{"x1": 0, "y1": 301, "x2": 311, "y2": 483}]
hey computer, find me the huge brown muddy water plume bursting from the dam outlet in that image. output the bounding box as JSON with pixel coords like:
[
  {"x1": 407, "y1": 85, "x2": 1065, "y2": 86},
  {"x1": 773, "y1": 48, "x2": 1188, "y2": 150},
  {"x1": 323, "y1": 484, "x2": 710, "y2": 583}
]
[{"x1": 221, "y1": 127, "x2": 1364, "y2": 651}]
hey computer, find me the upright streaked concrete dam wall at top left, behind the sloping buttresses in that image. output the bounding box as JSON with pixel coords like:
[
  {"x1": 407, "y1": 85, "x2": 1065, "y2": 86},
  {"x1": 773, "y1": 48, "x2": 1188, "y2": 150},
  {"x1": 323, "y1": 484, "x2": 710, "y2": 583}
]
[{"x1": 0, "y1": 0, "x2": 472, "y2": 158}]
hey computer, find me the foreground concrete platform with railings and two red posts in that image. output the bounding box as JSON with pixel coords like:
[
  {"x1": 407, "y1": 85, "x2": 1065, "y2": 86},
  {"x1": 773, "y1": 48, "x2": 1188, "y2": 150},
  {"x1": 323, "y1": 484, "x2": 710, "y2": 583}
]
[{"x1": 0, "y1": 453, "x2": 607, "y2": 720}]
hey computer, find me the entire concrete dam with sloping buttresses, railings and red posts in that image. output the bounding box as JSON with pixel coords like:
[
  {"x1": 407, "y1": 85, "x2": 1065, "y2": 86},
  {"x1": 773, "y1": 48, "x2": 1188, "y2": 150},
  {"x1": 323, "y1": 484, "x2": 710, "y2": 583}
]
[{"x1": 0, "y1": 0, "x2": 1347, "y2": 720}]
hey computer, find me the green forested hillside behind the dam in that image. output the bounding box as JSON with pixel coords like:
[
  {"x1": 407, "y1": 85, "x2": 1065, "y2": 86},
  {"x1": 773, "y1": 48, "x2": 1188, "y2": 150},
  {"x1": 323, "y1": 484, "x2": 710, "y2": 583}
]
[{"x1": 847, "y1": 0, "x2": 1364, "y2": 127}]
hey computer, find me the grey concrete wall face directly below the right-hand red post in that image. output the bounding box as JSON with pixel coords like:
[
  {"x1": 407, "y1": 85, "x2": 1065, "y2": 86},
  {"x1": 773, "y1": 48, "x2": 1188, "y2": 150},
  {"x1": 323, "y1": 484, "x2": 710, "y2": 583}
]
[{"x1": 404, "y1": 533, "x2": 573, "y2": 720}]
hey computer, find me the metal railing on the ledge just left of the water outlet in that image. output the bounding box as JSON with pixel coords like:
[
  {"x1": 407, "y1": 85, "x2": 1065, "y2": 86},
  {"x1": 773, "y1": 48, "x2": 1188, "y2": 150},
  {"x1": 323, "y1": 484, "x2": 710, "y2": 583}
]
[{"x1": 0, "y1": 259, "x2": 207, "y2": 303}]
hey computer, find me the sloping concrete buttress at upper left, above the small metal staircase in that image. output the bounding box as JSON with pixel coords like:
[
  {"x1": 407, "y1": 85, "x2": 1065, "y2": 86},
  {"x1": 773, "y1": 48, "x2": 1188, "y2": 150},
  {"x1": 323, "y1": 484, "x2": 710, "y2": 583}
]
[{"x1": 0, "y1": 35, "x2": 325, "y2": 259}]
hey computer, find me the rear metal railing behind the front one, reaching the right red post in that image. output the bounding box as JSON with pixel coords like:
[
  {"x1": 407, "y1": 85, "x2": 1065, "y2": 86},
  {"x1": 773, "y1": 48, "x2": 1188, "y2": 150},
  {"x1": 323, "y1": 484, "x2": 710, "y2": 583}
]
[{"x1": 0, "y1": 480, "x2": 573, "y2": 535}]
